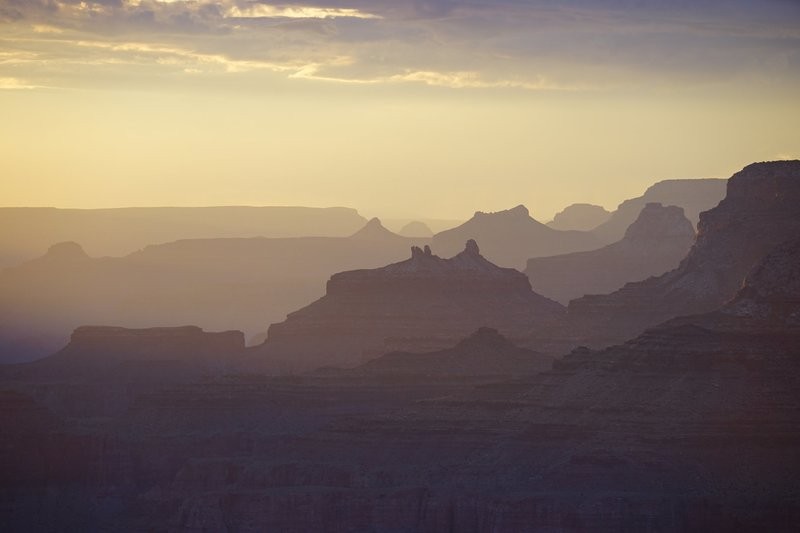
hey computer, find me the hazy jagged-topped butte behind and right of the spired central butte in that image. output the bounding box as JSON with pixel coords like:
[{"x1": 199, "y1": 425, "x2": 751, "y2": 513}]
[{"x1": 433, "y1": 205, "x2": 600, "y2": 269}]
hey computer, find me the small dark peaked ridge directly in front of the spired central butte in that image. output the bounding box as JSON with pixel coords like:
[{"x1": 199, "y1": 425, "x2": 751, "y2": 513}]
[{"x1": 354, "y1": 328, "x2": 553, "y2": 379}]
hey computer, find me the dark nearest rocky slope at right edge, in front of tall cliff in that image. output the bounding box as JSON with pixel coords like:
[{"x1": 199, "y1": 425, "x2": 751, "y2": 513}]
[{"x1": 558, "y1": 238, "x2": 800, "y2": 372}]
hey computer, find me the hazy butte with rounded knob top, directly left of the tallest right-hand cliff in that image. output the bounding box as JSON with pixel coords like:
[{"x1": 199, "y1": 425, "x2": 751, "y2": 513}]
[{"x1": 525, "y1": 203, "x2": 695, "y2": 304}]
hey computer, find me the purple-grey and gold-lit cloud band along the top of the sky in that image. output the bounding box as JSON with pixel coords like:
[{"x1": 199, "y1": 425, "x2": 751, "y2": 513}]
[{"x1": 0, "y1": 0, "x2": 800, "y2": 91}]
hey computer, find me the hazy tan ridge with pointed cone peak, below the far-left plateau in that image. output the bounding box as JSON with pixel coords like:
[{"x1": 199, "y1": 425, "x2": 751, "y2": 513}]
[{"x1": 0, "y1": 219, "x2": 427, "y2": 362}]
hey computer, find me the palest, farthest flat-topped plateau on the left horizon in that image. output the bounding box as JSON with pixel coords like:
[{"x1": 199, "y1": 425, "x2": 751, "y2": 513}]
[{"x1": 0, "y1": 206, "x2": 366, "y2": 268}]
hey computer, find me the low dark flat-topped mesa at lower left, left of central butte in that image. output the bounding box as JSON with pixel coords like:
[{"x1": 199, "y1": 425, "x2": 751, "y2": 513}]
[{"x1": 58, "y1": 326, "x2": 244, "y2": 361}]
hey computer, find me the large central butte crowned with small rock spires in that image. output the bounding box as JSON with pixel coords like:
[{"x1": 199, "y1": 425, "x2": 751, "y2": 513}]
[{"x1": 257, "y1": 240, "x2": 563, "y2": 370}]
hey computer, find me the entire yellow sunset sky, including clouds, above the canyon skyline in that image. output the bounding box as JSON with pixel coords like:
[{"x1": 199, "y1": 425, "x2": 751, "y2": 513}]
[{"x1": 0, "y1": 0, "x2": 800, "y2": 221}]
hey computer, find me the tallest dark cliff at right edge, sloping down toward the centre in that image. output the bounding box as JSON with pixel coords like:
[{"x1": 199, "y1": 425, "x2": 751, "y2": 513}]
[{"x1": 568, "y1": 161, "x2": 800, "y2": 346}]
